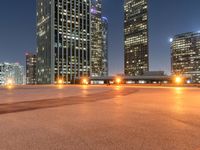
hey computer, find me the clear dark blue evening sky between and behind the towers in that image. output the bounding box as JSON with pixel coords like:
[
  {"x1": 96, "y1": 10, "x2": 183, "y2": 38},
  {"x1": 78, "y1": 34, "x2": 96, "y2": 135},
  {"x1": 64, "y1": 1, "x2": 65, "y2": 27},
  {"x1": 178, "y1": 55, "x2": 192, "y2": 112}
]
[{"x1": 0, "y1": 0, "x2": 200, "y2": 74}]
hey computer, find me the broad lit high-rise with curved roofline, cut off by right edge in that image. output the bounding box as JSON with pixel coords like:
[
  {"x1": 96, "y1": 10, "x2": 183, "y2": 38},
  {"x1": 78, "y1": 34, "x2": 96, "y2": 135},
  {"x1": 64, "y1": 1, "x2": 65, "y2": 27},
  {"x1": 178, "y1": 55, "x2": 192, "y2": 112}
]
[{"x1": 171, "y1": 32, "x2": 200, "y2": 83}]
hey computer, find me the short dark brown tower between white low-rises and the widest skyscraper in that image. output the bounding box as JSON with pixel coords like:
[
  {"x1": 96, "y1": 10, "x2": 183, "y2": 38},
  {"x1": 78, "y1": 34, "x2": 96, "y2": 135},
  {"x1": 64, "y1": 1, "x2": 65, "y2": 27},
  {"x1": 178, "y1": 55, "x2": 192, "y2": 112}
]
[{"x1": 26, "y1": 53, "x2": 37, "y2": 84}]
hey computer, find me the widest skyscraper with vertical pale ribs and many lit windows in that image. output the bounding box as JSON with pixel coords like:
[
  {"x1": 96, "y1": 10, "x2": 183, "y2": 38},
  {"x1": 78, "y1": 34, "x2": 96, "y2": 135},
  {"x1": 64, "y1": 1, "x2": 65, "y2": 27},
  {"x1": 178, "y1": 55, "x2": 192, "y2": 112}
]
[{"x1": 37, "y1": 0, "x2": 91, "y2": 84}]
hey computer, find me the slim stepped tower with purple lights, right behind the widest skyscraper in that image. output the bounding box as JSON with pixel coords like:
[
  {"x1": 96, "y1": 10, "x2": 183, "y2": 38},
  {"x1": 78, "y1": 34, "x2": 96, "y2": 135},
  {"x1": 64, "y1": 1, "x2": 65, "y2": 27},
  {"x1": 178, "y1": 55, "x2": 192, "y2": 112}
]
[{"x1": 91, "y1": 0, "x2": 108, "y2": 77}]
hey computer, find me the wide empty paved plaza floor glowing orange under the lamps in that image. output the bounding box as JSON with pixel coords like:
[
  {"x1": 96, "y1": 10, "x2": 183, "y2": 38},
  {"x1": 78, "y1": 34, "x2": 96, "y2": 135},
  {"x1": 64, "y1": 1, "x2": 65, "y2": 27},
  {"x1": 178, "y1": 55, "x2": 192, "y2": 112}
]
[{"x1": 0, "y1": 86, "x2": 200, "y2": 150}]
